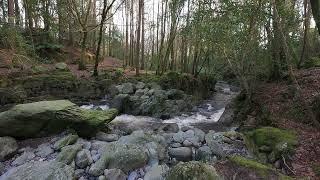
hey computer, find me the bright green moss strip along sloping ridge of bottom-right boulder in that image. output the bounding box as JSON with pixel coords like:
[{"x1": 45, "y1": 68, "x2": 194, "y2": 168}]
[{"x1": 229, "y1": 156, "x2": 292, "y2": 180}]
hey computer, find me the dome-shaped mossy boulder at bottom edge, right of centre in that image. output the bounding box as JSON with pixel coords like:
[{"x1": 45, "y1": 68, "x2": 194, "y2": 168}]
[{"x1": 167, "y1": 161, "x2": 222, "y2": 180}]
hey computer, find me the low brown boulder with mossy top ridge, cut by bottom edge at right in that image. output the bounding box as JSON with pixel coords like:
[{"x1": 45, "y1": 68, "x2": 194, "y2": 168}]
[{"x1": 216, "y1": 156, "x2": 292, "y2": 180}]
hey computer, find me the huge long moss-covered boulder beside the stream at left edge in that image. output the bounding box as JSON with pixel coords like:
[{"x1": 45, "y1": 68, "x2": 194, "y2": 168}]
[{"x1": 0, "y1": 100, "x2": 117, "y2": 138}]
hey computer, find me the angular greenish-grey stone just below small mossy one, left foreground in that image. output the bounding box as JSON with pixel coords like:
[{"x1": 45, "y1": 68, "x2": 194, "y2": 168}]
[{"x1": 56, "y1": 144, "x2": 82, "y2": 164}]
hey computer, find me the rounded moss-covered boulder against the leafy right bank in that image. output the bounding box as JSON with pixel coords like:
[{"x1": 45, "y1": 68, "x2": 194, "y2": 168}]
[{"x1": 245, "y1": 127, "x2": 298, "y2": 163}]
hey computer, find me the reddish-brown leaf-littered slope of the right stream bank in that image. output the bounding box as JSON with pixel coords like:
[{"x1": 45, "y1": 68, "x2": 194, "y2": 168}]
[{"x1": 254, "y1": 68, "x2": 320, "y2": 179}]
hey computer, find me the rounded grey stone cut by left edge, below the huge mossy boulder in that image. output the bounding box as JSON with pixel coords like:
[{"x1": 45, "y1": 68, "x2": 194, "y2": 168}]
[{"x1": 0, "y1": 137, "x2": 18, "y2": 161}]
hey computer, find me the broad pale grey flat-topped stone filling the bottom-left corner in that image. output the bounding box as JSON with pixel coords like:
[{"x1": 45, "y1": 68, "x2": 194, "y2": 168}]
[{"x1": 0, "y1": 161, "x2": 74, "y2": 180}]
